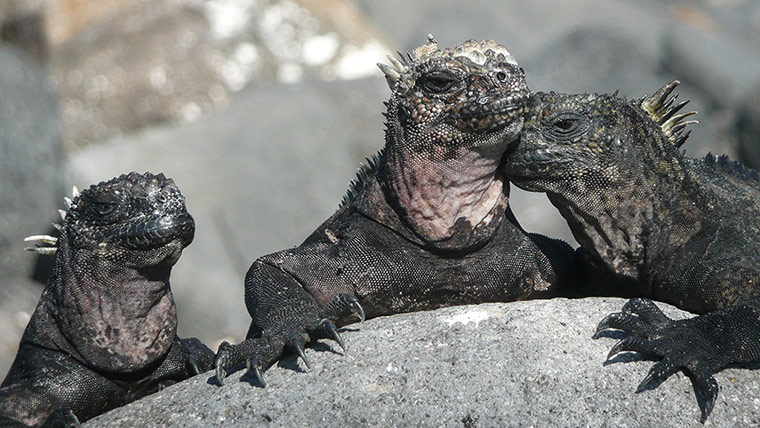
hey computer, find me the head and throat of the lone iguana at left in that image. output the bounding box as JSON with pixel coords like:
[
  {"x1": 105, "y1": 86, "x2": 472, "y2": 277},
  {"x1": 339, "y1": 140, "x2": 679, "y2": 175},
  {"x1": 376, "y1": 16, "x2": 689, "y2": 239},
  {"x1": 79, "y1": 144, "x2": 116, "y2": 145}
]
[{"x1": 32, "y1": 172, "x2": 195, "y2": 372}]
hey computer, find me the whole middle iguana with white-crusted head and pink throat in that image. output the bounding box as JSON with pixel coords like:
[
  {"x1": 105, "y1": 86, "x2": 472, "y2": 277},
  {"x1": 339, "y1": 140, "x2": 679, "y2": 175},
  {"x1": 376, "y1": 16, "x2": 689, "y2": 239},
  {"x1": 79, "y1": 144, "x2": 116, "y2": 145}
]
[{"x1": 215, "y1": 37, "x2": 573, "y2": 384}]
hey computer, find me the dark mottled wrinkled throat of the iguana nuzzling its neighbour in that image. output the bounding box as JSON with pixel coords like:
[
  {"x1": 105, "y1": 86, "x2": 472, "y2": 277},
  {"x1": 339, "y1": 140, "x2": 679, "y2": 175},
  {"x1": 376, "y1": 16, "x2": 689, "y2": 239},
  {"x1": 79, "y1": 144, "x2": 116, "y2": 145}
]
[{"x1": 546, "y1": 164, "x2": 701, "y2": 283}]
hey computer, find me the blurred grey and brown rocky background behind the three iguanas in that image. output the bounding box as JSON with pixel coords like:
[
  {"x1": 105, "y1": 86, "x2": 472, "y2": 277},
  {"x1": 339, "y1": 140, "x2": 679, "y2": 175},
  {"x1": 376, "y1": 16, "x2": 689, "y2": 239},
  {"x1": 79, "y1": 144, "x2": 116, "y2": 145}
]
[{"x1": 0, "y1": 0, "x2": 760, "y2": 375}]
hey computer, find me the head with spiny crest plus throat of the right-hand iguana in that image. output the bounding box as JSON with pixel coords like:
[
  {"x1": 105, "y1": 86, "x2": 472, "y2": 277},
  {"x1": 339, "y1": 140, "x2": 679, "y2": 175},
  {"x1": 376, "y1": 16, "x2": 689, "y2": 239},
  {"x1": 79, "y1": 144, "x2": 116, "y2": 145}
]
[{"x1": 504, "y1": 82, "x2": 694, "y2": 281}]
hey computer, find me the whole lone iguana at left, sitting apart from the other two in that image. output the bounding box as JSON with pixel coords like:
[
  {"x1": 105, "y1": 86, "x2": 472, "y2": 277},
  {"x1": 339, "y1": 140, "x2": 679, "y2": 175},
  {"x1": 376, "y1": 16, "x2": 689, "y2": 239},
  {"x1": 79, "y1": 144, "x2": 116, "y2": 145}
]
[{"x1": 0, "y1": 173, "x2": 214, "y2": 427}]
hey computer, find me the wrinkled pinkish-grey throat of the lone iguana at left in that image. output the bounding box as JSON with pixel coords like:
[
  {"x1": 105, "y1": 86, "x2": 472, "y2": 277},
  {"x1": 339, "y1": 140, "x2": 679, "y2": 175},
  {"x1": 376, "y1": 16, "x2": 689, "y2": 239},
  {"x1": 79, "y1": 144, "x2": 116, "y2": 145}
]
[{"x1": 48, "y1": 241, "x2": 181, "y2": 373}]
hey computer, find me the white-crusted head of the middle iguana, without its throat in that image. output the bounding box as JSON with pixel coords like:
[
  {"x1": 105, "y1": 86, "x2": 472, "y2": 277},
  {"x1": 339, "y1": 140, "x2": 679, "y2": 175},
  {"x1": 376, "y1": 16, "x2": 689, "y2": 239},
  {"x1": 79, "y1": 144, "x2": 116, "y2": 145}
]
[{"x1": 378, "y1": 36, "x2": 529, "y2": 160}]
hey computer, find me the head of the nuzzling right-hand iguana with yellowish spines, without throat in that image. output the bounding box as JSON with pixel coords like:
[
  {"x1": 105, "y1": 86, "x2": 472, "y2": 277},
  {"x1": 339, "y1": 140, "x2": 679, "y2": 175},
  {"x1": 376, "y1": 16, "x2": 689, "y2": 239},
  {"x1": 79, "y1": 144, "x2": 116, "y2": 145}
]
[{"x1": 505, "y1": 81, "x2": 695, "y2": 192}]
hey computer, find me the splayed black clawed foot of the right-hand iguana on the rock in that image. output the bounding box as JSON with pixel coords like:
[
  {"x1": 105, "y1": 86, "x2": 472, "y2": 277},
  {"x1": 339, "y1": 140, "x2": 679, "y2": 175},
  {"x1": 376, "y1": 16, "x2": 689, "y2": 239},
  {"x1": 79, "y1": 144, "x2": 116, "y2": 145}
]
[{"x1": 593, "y1": 298, "x2": 722, "y2": 422}]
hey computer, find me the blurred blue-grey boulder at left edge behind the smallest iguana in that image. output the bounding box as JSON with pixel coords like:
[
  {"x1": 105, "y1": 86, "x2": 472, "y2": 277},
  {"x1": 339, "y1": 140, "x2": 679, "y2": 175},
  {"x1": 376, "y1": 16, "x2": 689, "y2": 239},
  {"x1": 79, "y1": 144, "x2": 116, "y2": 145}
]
[{"x1": 0, "y1": 44, "x2": 63, "y2": 277}]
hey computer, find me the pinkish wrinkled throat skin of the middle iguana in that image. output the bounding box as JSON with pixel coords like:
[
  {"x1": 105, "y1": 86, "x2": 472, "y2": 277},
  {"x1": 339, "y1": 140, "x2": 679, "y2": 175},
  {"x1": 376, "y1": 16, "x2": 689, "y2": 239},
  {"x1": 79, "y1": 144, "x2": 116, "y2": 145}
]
[{"x1": 383, "y1": 135, "x2": 509, "y2": 250}]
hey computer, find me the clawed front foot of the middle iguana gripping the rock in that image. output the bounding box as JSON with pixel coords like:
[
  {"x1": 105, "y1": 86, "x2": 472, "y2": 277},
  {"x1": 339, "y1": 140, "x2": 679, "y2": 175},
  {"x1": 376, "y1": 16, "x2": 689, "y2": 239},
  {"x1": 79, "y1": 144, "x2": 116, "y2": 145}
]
[{"x1": 214, "y1": 294, "x2": 364, "y2": 386}]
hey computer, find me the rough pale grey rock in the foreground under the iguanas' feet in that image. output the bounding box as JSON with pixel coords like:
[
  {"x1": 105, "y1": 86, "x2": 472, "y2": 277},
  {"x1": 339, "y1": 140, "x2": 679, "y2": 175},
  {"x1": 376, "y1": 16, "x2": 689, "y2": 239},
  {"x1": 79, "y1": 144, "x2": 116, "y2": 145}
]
[{"x1": 85, "y1": 298, "x2": 760, "y2": 428}]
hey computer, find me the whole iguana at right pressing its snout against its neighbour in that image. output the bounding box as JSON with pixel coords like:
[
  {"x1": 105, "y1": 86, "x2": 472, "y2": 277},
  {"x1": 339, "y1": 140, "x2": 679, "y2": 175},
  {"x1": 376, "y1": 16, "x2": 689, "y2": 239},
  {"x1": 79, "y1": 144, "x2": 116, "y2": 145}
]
[{"x1": 505, "y1": 81, "x2": 760, "y2": 422}]
